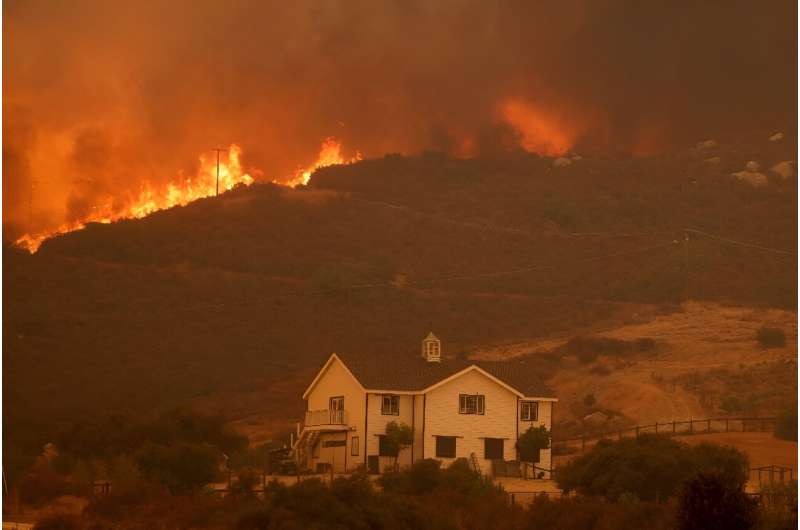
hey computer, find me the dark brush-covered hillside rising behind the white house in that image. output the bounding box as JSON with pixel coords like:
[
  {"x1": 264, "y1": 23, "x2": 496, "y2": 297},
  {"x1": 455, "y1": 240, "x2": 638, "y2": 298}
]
[{"x1": 3, "y1": 135, "x2": 797, "y2": 456}]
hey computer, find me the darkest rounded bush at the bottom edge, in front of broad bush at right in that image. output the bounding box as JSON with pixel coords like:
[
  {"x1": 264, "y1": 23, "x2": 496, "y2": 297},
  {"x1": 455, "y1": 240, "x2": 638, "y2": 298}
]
[{"x1": 677, "y1": 472, "x2": 757, "y2": 530}]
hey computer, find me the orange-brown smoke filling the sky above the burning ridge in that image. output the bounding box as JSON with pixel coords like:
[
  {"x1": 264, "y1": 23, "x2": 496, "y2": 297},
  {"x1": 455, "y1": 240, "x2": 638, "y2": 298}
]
[{"x1": 3, "y1": 0, "x2": 797, "y2": 233}]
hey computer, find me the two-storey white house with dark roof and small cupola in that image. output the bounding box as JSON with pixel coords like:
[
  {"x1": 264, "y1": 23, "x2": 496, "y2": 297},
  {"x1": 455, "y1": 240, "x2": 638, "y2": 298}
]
[{"x1": 294, "y1": 333, "x2": 558, "y2": 473}]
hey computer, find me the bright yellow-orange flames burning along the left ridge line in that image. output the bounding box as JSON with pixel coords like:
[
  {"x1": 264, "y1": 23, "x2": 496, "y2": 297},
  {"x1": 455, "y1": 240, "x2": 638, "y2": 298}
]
[{"x1": 15, "y1": 138, "x2": 361, "y2": 253}]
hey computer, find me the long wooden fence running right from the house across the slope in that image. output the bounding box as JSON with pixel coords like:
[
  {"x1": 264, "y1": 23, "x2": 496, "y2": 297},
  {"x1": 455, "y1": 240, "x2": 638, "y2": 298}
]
[{"x1": 552, "y1": 417, "x2": 777, "y2": 454}]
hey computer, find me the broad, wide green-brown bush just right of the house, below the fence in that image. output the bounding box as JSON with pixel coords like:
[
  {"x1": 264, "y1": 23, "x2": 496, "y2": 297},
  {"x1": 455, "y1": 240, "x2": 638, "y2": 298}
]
[{"x1": 556, "y1": 434, "x2": 748, "y2": 501}]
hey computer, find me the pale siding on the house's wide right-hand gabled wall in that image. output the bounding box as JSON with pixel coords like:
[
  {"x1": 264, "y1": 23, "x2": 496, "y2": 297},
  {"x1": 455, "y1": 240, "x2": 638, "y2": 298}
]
[{"x1": 424, "y1": 370, "x2": 517, "y2": 473}]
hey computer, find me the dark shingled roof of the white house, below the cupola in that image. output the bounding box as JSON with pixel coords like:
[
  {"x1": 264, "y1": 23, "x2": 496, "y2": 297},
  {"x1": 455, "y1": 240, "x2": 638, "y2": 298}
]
[{"x1": 336, "y1": 353, "x2": 555, "y2": 398}]
